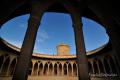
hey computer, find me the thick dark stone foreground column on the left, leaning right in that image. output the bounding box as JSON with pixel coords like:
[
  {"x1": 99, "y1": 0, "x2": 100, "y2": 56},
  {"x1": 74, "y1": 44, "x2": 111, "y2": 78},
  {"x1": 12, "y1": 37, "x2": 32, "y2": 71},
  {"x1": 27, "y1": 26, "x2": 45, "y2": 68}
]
[{"x1": 12, "y1": 5, "x2": 42, "y2": 80}]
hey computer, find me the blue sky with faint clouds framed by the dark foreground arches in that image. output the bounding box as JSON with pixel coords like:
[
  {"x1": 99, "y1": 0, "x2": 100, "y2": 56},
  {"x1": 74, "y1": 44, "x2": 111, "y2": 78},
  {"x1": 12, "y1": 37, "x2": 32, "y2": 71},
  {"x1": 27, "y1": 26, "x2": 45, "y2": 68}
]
[{"x1": 0, "y1": 13, "x2": 109, "y2": 55}]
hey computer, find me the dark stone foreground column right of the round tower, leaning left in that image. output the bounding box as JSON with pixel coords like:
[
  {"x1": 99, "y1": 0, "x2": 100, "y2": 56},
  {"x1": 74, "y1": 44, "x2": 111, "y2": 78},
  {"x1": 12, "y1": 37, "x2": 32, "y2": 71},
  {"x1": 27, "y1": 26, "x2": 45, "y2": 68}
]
[{"x1": 71, "y1": 14, "x2": 89, "y2": 80}]
